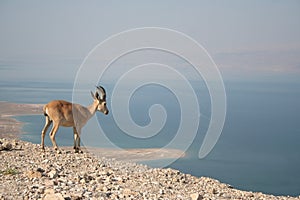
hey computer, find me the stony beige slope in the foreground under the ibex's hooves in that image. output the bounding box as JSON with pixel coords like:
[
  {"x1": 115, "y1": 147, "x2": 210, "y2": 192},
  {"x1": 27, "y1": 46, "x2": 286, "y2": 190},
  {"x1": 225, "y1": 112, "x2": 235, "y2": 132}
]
[{"x1": 0, "y1": 139, "x2": 300, "y2": 200}]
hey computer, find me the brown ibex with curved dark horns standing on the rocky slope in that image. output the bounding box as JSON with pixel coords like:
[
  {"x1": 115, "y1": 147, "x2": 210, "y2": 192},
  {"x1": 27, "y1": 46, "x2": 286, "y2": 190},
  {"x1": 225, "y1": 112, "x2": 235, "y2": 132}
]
[{"x1": 41, "y1": 86, "x2": 109, "y2": 153}]
